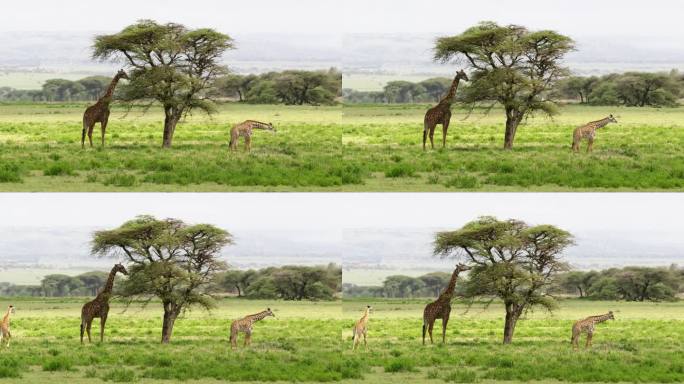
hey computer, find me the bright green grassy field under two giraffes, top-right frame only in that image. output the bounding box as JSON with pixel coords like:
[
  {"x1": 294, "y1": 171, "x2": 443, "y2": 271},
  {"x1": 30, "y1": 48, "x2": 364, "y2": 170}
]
[{"x1": 343, "y1": 105, "x2": 684, "y2": 191}]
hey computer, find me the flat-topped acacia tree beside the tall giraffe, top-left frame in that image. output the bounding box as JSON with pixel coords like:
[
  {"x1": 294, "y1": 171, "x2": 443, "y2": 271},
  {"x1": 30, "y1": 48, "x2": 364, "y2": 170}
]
[{"x1": 93, "y1": 20, "x2": 234, "y2": 148}]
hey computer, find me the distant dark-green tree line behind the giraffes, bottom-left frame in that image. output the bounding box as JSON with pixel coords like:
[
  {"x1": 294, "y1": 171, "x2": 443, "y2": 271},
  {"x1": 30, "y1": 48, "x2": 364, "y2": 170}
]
[{"x1": 0, "y1": 264, "x2": 342, "y2": 300}]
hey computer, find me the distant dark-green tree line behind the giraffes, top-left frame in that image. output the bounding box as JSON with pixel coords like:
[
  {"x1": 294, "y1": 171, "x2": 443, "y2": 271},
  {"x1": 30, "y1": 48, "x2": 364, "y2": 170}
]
[{"x1": 0, "y1": 68, "x2": 342, "y2": 105}]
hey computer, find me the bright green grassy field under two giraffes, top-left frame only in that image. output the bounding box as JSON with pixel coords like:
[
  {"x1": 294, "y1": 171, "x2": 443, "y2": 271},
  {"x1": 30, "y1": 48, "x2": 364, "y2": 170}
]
[{"x1": 0, "y1": 103, "x2": 344, "y2": 191}]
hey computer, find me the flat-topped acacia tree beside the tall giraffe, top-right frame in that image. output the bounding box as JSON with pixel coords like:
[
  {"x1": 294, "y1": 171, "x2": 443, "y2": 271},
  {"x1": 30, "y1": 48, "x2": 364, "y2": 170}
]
[{"x1": 434, "y1": 22, "x2": 574, "y2": 149}]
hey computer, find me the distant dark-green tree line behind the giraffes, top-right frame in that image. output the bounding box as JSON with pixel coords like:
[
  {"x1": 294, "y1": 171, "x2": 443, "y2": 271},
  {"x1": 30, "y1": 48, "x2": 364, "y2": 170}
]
[{"x1": 342, "y1": 69, "x2": 684, "y2": 107}]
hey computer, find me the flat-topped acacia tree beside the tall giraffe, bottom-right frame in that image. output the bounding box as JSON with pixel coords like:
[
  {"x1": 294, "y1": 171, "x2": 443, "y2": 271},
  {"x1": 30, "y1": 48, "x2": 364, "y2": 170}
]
[{"x1": 434, "y1": 216, "x2": 573, "y2": 344}]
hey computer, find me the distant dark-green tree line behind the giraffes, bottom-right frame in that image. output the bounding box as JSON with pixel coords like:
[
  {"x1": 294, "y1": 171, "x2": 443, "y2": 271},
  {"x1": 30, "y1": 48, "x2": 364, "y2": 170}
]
[{"x1": 342, "y1": 265, "x2": 684, "y2": 301}]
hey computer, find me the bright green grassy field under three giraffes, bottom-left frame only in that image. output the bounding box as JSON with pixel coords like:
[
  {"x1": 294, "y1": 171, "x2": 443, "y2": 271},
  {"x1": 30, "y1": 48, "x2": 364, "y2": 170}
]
[{"x1": 0, "y1": 298, "x2": 352, "y2": 383}]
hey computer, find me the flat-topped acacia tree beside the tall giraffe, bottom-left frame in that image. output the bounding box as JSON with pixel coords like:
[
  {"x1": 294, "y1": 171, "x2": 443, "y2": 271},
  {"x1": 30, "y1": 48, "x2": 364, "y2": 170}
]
[{"x1": 92, "y1": 216, "x2": 232, "y2": 343}]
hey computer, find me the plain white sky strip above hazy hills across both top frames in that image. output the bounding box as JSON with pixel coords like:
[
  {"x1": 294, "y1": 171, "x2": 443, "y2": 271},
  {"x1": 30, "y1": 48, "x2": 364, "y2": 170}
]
[{"x1": 0, "y1": 0, "x2": 684, "y2": 37}]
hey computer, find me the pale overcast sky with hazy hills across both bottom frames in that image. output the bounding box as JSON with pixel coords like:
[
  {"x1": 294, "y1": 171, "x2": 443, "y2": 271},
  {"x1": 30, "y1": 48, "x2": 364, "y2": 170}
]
[{"x1": 0, "y1": 193, "x2": 684, "y2": 274}]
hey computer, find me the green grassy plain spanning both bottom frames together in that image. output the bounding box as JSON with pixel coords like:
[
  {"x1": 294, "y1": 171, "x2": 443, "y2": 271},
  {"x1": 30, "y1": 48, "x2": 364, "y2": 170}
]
[{"x1": 0, "y1": 298, "x2": 684, "y2": 383}]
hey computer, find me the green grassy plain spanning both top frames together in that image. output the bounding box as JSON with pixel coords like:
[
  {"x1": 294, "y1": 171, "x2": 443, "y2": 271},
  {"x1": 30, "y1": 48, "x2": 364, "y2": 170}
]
[{"x1": 0, "y1": 103, "x2": 684, "y2": 191}]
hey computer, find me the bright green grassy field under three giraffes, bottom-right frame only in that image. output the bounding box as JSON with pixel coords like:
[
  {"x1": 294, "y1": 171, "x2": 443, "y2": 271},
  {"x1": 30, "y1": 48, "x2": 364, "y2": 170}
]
[{"x1": 343, "y1": 299, "x2": 684, "y2": 383}]
